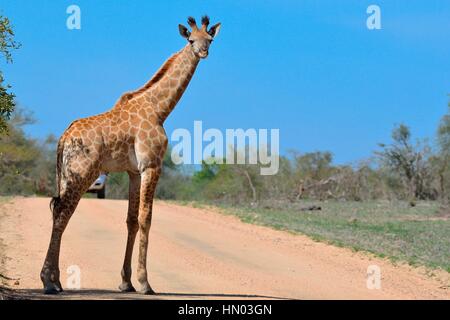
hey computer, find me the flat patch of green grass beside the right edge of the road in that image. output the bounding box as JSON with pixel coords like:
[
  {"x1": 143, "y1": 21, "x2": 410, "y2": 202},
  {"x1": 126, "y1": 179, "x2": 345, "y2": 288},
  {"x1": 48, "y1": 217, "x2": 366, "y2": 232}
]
[{"x1": 171, "y1": 201, "x2": 450, "y2": 272}]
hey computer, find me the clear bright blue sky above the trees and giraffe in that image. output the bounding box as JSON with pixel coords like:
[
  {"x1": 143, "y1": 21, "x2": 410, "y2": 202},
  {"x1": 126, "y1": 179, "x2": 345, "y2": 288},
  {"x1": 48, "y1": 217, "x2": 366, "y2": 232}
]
[{"x1": 0, "y1": 0, "x2": 450, "y2": 163}]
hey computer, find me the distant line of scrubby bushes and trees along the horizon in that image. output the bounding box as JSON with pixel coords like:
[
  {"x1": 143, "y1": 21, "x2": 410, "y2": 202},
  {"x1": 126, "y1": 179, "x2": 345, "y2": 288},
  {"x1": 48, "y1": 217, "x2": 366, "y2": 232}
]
[{"x1": 0, "y1": 105, "x2": 450, "y2": 206}]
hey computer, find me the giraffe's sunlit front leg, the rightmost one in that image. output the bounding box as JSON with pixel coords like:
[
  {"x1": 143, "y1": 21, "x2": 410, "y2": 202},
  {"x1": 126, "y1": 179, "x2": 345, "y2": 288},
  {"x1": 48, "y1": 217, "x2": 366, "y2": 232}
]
[{"x1": 137, "y1": 168, "x2": 161, "y2": 294}]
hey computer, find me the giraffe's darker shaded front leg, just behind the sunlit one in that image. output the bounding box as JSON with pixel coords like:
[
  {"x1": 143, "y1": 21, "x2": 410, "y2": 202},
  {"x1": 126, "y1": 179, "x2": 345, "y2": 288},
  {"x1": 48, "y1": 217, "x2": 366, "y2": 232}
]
[{"x1": 119, "y1": 172, "x2": 141, "y2": 292}]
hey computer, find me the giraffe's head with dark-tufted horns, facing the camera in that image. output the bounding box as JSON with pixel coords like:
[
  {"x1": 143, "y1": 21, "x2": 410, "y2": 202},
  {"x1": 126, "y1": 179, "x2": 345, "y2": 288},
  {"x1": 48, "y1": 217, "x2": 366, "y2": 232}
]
[{"x1": 178, "y1": 16, "x2": 220, "y2": 59}]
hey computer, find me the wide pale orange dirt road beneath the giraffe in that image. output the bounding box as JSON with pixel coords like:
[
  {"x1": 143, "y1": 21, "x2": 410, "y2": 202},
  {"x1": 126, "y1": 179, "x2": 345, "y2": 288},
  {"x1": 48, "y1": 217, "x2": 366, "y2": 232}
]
[{"x1": 0, "y1": 198, "x2": 450, "y2": 299}]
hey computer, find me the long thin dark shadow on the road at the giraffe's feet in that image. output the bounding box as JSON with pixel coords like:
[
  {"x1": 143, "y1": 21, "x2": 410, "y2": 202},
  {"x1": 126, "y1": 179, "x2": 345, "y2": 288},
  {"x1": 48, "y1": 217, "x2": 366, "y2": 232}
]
[{"x1": 4, "y1": 289, "x2": 289, "y2": 300}]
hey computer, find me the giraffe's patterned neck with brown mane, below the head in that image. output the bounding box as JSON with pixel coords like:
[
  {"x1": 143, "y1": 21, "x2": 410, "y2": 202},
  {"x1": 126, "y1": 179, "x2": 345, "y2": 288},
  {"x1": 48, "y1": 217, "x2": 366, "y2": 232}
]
[{"x1": 125, "y1": 44, "x2": 200, "y2": 124}]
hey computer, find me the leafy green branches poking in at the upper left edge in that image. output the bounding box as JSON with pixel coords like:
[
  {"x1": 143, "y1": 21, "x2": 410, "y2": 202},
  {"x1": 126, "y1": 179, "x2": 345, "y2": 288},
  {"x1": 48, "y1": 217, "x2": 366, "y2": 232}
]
[{"x1": 0, "y1": 15, "x2": 20, "y2": 133}]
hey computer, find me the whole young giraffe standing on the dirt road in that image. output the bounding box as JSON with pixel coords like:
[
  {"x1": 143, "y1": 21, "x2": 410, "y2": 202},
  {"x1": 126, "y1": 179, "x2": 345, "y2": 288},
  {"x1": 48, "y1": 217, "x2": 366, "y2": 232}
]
[{"x1": 41, "y1": 16, "x2": 220, "y2": 294}]
